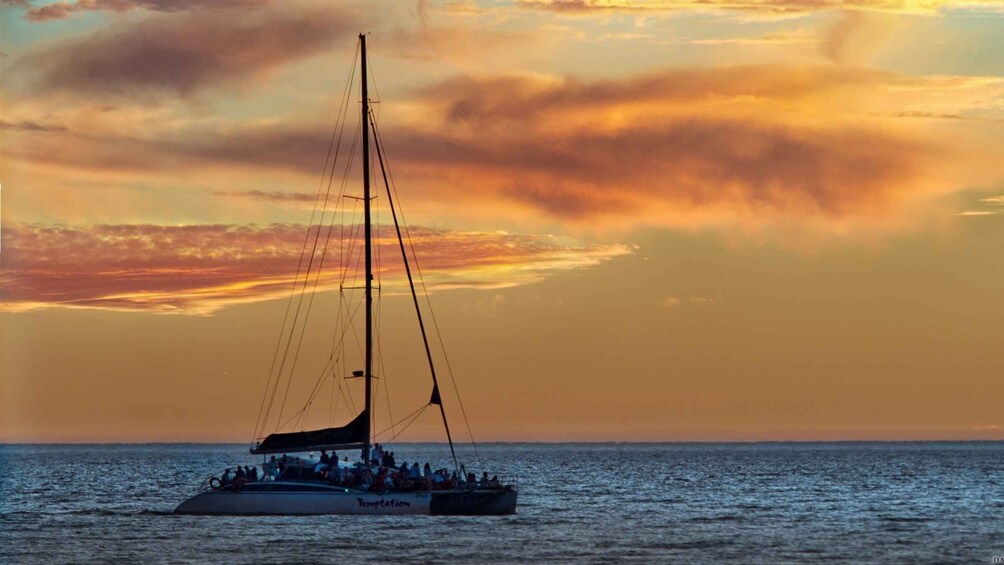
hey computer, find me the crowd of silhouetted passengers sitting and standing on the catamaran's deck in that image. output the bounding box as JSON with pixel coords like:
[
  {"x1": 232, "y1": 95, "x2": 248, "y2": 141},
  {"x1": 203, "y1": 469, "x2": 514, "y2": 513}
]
[{"x1": 220, "y1": 444, "x2": 501, "y2": 493}]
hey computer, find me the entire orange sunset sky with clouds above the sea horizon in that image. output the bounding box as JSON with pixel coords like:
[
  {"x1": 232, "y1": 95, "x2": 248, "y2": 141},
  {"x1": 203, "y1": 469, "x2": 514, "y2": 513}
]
[{"x1": 0, "y1": 0, "x2": 1004, "y2": 442}]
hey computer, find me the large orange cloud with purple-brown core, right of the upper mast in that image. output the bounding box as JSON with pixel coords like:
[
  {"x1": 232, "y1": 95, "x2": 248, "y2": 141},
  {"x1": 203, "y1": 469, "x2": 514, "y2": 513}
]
[{"x1": 375, "y1": 65, "x2": 1004, "y2": 230}]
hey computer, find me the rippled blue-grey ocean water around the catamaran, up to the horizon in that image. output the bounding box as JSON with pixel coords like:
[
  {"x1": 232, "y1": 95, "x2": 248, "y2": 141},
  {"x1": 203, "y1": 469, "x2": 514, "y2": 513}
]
[{"x1": 0, "y1": 443, "x2": 1004, "y2": 565}]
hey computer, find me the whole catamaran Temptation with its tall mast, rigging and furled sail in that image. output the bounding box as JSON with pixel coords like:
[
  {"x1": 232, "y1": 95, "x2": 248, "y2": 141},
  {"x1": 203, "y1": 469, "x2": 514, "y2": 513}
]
[{"x1": 175, "y1": 34, "x2": 517, "y2": 515}]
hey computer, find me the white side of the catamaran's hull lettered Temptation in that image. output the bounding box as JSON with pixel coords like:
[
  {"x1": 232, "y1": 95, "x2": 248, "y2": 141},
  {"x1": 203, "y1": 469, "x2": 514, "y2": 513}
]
[{"x1": 175, "y1": 491, "x2": 432, "y2": 515}]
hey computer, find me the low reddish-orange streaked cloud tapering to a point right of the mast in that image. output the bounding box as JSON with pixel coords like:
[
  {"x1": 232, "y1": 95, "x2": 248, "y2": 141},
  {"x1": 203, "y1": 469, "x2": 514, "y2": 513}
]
[{"x1": 0, "y1": 224, "x2": 631, "y2": 314}]
